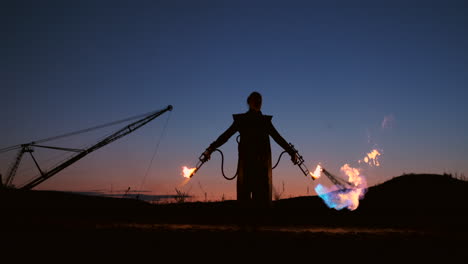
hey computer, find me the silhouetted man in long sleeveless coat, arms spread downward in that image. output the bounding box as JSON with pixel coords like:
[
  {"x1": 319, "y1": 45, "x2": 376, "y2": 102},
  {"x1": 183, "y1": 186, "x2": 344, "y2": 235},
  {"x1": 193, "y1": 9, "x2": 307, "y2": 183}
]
[{"x1": 203, "y1": 92, "x2": 297, "y2": 207}]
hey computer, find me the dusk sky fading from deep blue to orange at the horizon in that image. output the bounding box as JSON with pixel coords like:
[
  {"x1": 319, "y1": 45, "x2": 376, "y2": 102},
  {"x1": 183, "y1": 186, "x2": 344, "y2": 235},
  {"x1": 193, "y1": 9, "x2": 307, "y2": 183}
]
[{"x1": 0, "y1": 1, "x2": 468, "y2": 199}]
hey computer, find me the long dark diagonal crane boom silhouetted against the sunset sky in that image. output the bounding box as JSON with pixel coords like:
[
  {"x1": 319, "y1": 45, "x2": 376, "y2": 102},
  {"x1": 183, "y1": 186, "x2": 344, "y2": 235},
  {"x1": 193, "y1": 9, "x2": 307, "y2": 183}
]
[{"x1": 20, "y1": 105, "x2": 173, "y2": 190}]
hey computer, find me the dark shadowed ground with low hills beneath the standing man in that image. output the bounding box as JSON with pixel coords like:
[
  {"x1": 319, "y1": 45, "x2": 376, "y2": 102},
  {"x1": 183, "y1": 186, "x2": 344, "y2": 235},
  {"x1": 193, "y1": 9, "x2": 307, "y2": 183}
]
[{"x1": 0, "y1": 175, "x2": 468, "y2": 263}]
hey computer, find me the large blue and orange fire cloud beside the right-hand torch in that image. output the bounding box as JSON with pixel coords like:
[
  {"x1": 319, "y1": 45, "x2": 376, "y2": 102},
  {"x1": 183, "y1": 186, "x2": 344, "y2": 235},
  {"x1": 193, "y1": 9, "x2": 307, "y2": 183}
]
[{"x1": 315, "y1": 164, "x2": 367, "y2": 211}]
